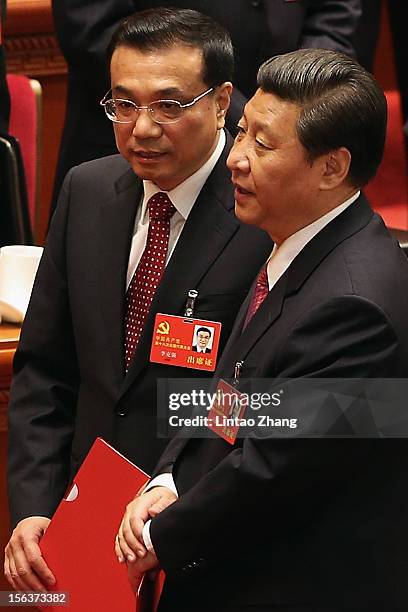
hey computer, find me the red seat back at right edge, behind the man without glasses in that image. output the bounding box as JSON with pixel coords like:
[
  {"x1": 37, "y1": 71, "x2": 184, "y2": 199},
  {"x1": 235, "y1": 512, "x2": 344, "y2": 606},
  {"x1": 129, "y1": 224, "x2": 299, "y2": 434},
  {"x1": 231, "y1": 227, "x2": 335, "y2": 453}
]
[{"x1": 364, "y1": 90, "x2": 408, "y2": 230}]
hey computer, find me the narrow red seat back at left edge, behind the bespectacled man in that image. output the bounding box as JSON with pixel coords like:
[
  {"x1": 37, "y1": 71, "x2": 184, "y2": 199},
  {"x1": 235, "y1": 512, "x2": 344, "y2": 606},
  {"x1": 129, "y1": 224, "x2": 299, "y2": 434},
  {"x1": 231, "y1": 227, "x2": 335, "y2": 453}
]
[{"x1": 7, "y1": 74, "x2": 42, "y2": 241}]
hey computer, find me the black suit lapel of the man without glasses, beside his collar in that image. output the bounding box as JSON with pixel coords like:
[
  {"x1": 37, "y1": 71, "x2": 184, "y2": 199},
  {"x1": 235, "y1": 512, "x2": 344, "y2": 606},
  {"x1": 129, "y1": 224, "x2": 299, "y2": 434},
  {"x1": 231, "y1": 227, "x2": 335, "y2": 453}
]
[{"x1": 215, "y1": 196, "x2": 373, "y2": 378}]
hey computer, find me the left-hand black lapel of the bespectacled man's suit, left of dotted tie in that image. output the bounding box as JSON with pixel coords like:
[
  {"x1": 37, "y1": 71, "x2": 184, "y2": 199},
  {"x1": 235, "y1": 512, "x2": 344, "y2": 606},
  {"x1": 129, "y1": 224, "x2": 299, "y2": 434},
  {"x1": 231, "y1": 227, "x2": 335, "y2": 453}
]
[{"x1": 99, "y1": 170, "x2": 142, "y2": 385}]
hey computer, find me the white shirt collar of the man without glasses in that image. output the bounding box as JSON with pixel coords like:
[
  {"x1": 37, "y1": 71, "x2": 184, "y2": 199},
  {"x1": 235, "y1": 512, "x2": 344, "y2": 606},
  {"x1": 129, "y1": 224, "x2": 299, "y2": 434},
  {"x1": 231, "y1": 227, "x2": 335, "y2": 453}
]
[{"x1": 267, "y1": 191, "x2": 360, "y2": 289}]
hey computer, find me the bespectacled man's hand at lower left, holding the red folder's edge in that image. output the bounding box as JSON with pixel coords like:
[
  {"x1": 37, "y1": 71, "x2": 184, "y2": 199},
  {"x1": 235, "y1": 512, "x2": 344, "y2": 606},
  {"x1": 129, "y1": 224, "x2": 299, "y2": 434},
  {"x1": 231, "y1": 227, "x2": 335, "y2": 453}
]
[{"x1": 4, "y1": 516, "x2": 55, "y2": 591}]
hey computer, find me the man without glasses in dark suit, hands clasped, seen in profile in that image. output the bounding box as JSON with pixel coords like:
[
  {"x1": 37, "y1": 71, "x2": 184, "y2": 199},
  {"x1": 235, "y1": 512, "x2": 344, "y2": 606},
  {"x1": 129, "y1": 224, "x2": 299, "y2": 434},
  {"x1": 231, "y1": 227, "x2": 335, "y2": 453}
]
[{"x1": 116, "y1": 50, "x2": 408, "y2": 612}]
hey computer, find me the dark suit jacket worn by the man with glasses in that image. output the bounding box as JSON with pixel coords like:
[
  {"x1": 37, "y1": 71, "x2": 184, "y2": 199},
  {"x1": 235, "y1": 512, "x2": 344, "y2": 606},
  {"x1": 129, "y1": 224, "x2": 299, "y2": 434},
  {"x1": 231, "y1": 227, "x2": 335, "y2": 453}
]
[{"x1": 9, "y1": 139, "x2": 272, "y2": 521}]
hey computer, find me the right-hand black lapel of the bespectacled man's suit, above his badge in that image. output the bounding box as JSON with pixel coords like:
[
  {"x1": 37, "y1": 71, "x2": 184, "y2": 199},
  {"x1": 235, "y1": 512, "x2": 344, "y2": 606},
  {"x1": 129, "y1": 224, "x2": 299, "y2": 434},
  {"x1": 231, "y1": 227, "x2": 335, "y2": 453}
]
[{"x1": 121, "y1": 138, "x2": 239, "y2": 394}]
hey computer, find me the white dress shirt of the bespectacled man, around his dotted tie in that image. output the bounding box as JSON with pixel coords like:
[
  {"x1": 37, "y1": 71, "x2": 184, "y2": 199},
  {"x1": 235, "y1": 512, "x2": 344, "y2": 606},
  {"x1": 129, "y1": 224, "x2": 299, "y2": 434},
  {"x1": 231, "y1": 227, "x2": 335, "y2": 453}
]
[{"x1": 126, "y1": 130, "x2": 227, "y2": 290}]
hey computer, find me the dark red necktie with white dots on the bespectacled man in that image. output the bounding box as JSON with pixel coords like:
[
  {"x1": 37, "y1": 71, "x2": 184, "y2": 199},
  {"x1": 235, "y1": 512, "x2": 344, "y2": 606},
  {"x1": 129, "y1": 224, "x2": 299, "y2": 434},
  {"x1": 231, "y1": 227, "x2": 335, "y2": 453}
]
[{"x1": 125, "y1": 192, "x2": 176, "y2": 371}]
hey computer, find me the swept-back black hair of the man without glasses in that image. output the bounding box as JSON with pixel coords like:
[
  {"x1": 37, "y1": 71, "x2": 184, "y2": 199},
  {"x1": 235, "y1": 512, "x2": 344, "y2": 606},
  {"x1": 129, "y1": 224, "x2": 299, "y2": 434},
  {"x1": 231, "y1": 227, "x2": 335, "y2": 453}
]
[{"x1": 258, "y1": 49, "x2": 387, "y2": 187}]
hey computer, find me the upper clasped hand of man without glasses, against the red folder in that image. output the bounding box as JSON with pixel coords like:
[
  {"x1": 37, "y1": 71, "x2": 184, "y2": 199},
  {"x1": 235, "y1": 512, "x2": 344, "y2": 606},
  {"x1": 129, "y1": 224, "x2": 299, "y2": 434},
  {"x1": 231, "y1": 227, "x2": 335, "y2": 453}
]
[{"x1": 115, "y1": 487, "x2": 177, "y2": 563}]
